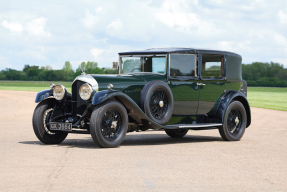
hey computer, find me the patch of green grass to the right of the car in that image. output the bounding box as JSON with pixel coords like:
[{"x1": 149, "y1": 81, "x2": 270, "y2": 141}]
[{"x1": 247, "y1": 87, "x2": 287, "y2": 111}]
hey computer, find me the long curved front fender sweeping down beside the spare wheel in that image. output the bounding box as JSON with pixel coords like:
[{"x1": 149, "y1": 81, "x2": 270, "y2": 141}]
[{"x1": 92, "y1": 90, "x2": 168, "y2": 129}]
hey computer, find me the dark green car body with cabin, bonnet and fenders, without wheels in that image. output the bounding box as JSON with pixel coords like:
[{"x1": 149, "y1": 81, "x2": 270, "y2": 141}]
[{"x1": 36, "y1": 48, "x2": 251, "y2": 146}]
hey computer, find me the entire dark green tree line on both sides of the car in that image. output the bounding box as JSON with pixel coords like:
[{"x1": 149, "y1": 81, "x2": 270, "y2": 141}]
[{"x1": 0, "y1": 61, "x2": 287, "y2": 87}]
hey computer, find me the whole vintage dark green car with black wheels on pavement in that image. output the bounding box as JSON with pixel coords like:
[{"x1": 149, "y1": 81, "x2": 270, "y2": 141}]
[{"x1": 33, "y1": 48, "x2": 251, "y2": 147}]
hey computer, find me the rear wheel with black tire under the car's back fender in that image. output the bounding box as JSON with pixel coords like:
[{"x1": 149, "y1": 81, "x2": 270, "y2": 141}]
[{"x1": 219, "y1": 101, "x2": 247, "y2": 141}]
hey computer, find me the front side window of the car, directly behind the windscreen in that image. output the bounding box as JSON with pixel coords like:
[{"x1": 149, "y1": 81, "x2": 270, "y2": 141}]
[{"x1": 170, "y1": 54, "x2": 197, "y2": 77}]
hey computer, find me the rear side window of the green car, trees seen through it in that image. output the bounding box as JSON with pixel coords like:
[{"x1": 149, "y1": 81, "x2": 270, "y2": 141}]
[{"x1": 201, "y1": 54, "x2": 223, "y2": 78}]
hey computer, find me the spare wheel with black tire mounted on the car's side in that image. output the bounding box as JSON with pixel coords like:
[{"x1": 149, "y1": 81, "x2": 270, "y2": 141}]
[{"x1": 140, "y1": 80, "x2": 173, "y2": 125}]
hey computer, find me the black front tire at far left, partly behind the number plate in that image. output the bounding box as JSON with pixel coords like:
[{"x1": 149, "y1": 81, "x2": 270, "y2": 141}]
[{"x1": 32, "y1": 99, "x2": 68, "y2": 144}]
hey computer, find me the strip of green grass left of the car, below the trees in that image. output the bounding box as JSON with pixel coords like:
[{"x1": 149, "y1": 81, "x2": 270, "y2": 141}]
[{"x1": 0, "y1": 81, "x2": 72, "y2": 92}]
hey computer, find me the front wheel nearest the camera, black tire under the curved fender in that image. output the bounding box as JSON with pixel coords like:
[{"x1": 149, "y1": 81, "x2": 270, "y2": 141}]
[{"x1": 90, "y1": 100, "x2": 128, "y2": 148}]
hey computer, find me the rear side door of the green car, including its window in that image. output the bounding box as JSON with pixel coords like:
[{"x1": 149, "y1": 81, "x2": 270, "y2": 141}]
[{"x1": 197, "y1": 54, "x2": 225, "y2": 114}]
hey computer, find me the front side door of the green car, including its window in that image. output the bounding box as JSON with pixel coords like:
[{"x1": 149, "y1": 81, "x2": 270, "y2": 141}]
[{"x1": 168, "y1": 54, "x2": 199, "y2": 115}]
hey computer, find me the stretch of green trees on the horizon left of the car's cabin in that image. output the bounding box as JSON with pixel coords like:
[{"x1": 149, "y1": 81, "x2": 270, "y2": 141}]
[{"x1": 0, "y1": 61, "x2": 118, "y2": 81}]
